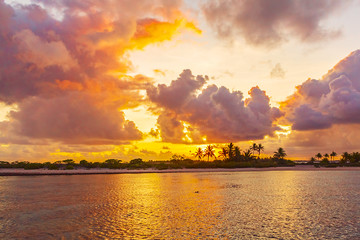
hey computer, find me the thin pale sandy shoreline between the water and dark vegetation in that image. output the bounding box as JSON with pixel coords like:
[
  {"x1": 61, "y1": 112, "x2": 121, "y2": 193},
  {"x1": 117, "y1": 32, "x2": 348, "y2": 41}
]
[{"x1": 0, "y1": 165, "x2": 360, "y2": 176}]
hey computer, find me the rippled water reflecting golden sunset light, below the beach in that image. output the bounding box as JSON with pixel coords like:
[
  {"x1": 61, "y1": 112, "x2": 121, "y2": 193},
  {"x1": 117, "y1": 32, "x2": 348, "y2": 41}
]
[{"x1": 0, "y1": 171, "x2": 360, "y2": 239}]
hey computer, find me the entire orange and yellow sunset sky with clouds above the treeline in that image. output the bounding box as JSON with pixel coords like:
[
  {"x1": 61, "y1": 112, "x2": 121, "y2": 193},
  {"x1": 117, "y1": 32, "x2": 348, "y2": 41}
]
[{"x1": 0, "y1": 0, "x2": 360, "y2": 162}]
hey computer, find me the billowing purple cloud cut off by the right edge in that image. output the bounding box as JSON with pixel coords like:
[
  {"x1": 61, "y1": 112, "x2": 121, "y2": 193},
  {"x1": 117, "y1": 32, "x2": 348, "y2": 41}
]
[{"x1": 281, "y1": 50, "x2": 360, "y2": 130}]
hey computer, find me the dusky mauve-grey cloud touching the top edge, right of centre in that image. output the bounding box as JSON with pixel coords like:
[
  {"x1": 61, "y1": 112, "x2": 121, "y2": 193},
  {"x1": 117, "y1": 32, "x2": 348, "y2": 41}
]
[{"x1": 203, "y1": 0, "x2": 349, "y2": 48}]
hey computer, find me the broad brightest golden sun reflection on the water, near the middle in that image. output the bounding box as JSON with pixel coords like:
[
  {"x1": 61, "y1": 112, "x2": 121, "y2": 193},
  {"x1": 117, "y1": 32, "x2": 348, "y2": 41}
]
[{"x1": 108, "y1": 173, "x2": 222, "y2": 238}]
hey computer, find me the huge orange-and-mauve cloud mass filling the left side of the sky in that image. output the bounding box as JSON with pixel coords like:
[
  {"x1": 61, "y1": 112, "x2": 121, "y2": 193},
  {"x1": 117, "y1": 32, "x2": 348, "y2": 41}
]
[{"x1": 0, "y1": 0, "x2": 200, "y2": 144}]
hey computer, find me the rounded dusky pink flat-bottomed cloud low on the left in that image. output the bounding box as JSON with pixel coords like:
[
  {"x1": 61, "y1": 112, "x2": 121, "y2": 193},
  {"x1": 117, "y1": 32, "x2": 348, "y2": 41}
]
[{"x1": 3, "y1": 93, "x2": 142, "y2": 144}]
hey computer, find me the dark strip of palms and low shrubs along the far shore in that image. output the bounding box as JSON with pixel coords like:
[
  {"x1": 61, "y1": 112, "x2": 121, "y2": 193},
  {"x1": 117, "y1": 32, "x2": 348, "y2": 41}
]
[{"x1": 0, "y1": 143, "x2": 360, "y2": 170}]
